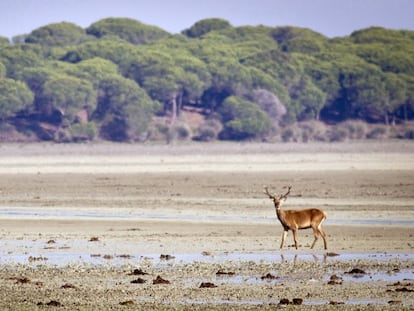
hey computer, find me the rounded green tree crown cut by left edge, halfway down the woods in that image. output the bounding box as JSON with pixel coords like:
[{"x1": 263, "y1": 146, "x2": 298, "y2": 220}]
[{"x1": 0, "y1": 78, "x2": 33, "y2": 121}]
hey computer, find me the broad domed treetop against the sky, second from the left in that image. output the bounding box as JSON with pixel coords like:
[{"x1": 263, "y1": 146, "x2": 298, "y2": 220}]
[{"x1": 86, "y1": 18, "x2": 169, "y2": 44}]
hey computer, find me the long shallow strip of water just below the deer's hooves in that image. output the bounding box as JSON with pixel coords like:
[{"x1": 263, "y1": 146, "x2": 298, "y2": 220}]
[{"x1": 0, "y1": 238, "x2": 414, "y2": 266}]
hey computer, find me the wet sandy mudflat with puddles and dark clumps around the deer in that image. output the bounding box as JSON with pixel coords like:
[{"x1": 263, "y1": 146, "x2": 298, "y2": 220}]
[{"x1": 0, "y1": 142, "x2": 414, "y2": 310}]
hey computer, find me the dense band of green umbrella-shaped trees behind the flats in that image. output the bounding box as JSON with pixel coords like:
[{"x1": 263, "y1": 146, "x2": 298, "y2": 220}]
[{"x1": 0, "y1": 18, "x2": 414, "y2": 141}]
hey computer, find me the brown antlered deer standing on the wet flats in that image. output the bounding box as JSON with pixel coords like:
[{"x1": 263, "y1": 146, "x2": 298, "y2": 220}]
[{"x1": 264, "y1": 186, "x2": 328, "y2": 249}]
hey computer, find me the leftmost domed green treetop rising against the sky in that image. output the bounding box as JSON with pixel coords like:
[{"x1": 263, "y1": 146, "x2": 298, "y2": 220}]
[{"x1": 25, "y1": 22, "x2": 87, "y2": 46}]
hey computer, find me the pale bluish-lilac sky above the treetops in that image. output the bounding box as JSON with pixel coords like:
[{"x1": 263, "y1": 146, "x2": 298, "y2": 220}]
[{"x1": 0, "y1": 0, "x2": 414, "y2": 38}]
